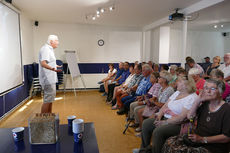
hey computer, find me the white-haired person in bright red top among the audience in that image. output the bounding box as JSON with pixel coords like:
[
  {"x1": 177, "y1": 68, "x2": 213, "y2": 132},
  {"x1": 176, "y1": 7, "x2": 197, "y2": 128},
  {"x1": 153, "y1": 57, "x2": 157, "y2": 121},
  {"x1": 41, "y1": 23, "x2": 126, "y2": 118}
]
[{"x1": 188, "y1": 68, "x2": 205, "y2": 95}]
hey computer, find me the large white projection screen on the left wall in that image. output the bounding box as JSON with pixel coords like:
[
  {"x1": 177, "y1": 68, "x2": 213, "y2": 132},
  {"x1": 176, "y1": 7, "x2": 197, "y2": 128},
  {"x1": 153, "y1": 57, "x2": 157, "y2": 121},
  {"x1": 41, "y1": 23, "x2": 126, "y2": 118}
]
[{"x1": 0, "y1": 2, "x2": 23, "y2": 95}]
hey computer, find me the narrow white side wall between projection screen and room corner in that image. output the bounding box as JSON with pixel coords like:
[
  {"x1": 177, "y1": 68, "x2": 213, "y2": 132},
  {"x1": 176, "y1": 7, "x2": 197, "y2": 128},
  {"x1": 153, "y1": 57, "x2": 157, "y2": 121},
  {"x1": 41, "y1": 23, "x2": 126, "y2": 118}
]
[{"x1": 20, "y1": 14, "x2": 35, "y2": 65}]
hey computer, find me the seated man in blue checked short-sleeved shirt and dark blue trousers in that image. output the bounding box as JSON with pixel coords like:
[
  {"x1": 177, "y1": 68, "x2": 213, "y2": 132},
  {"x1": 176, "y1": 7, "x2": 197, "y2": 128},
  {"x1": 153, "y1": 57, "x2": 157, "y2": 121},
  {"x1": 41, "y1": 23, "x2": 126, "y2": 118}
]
[{"x1": 117, "y1": 64, "x2": 152, "y2": 115}]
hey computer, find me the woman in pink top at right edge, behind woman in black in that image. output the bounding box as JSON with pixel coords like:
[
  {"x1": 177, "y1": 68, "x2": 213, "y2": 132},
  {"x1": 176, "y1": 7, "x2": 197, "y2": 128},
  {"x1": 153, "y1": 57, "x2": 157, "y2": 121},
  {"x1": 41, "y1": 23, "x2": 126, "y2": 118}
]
[{"x1": 210, "y1": 69, "x2": 230, "y2": 100}]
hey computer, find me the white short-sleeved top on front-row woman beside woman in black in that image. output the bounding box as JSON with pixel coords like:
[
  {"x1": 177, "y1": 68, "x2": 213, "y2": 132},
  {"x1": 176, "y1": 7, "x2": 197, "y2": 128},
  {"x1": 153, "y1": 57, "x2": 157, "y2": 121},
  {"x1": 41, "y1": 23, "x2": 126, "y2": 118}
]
[{"x1": 164, "y1": 91, "x2": 197, "y2": 118}]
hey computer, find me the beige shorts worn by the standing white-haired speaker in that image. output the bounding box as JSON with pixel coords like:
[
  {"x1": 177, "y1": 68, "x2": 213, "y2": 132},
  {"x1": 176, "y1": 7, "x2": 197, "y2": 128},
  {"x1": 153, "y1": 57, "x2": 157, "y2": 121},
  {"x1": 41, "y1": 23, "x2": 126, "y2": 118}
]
[{"x1": 43, "y1": 84, "x2": 56, "y2": 103}]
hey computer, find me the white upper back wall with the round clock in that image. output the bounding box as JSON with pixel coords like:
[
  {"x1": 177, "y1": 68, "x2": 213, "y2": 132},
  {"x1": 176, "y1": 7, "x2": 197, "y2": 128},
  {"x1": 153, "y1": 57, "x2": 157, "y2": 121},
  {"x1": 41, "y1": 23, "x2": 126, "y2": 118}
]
[{"x1": 33, "y1": 22, "x2": 141, "y2": 63}]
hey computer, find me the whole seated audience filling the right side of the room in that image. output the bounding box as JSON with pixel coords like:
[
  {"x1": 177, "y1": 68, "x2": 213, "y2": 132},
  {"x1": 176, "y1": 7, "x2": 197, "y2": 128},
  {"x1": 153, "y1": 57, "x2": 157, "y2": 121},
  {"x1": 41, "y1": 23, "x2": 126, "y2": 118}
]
[{"x1": 98, "y1": 53, "x2": 230, "y2": 153}]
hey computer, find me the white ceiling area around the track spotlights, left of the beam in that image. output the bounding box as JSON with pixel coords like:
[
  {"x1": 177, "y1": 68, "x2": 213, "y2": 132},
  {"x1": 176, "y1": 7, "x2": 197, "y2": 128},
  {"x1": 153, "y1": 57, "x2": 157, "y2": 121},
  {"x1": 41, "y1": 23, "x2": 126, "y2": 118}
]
[{"x1": 13, "y1": 0, "x2": 200, "y2": 27}]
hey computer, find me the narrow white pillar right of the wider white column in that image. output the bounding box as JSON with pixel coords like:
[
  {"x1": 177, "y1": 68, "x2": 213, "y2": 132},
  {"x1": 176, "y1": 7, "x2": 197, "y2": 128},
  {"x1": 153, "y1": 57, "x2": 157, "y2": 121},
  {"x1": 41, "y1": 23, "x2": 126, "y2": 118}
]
[{"x1": 181, "y1": 21, "x2": 188, "y2": 67}]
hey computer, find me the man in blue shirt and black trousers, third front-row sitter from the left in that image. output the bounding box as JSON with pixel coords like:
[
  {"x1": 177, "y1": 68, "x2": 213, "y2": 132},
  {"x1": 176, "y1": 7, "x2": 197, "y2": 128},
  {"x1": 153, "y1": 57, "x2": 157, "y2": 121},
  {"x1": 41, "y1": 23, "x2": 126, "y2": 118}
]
[{"x1": 106, "y1": 62, "x2": 130, "y2": 102}]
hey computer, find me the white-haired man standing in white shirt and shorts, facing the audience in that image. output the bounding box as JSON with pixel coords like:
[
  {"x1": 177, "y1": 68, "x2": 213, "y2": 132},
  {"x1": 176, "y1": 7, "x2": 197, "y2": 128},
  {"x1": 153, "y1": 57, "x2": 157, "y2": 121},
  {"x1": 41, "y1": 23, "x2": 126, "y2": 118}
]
[{"x1": 39, "y1": 35, "x2": 61, "y2": 113}]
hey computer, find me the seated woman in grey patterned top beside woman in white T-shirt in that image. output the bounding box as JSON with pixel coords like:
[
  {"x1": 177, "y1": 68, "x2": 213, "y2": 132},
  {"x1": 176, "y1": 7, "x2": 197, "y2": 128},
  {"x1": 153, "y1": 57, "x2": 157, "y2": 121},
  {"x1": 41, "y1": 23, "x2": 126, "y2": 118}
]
[{"x1": 135, "y1": 71, "x2": 174, "y2": 132}]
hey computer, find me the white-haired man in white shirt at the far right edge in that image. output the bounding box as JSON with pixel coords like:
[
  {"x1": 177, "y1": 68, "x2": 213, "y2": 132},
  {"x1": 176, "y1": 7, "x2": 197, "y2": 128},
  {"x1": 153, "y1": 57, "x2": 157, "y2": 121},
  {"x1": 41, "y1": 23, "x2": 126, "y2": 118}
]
[{"x1": 218, "y1": 53, "x2": 230, "y2": 83}]
